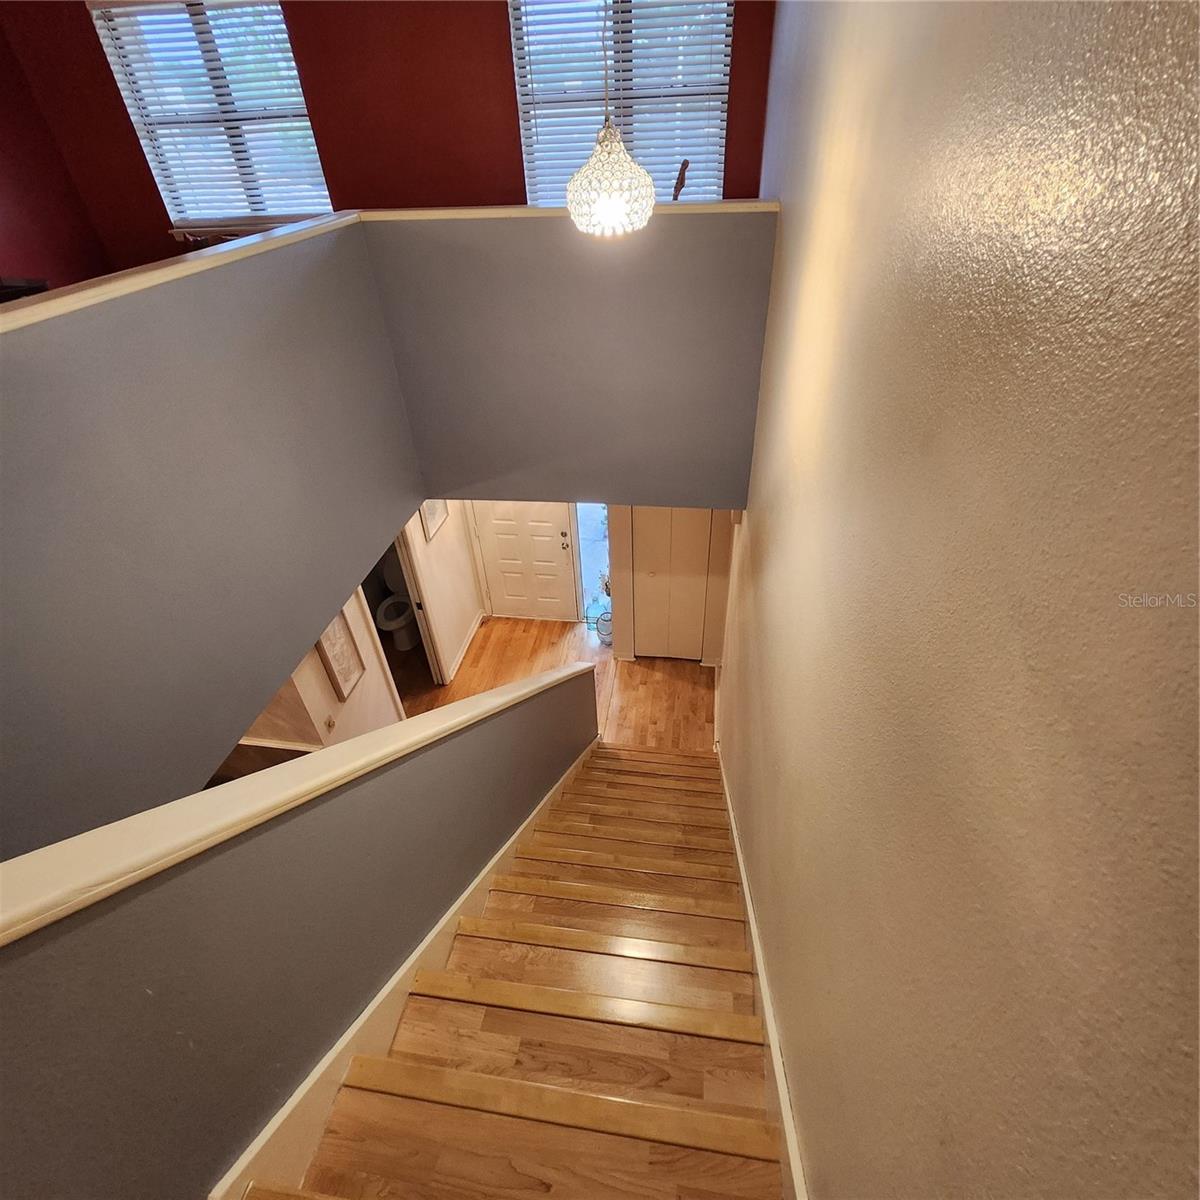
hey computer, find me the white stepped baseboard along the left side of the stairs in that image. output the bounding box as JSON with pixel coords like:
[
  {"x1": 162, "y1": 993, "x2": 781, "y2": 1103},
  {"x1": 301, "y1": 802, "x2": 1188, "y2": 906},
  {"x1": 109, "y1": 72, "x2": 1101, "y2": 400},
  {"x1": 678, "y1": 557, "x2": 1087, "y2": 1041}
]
[{"x1": 209, "y1": 742, "x2": 595, "y2": 1200}]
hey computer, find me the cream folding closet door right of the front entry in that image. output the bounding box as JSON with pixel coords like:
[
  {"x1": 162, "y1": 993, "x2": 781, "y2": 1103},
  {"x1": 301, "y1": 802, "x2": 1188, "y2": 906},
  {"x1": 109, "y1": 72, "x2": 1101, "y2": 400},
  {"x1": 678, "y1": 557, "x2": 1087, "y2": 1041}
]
[{"x1": 634, "y1": 508, "x2": 713, "y2": 660}]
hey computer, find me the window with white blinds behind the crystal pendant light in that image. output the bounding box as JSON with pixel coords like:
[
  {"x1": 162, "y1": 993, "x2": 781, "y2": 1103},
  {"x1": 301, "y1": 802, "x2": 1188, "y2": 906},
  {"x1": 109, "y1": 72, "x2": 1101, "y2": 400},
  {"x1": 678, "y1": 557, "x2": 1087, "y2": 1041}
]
[{"x1": 509, "y1": 0, "x2": 733, "y2": 205}]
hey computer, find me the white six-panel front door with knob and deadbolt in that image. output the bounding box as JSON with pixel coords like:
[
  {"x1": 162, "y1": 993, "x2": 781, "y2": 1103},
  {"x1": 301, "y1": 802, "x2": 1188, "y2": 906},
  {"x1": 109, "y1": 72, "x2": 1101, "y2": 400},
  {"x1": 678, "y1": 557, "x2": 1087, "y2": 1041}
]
[{"x1": 472, "y1": 500, "x2": 580, "y2": 620}]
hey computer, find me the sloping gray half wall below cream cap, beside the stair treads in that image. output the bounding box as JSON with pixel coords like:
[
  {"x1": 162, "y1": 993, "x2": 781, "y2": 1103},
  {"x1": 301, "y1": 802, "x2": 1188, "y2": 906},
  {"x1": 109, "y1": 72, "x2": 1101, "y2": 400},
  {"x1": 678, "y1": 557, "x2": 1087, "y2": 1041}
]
[{"x1": 0, "y1": 674, "x2": 596, "y2": 1200}]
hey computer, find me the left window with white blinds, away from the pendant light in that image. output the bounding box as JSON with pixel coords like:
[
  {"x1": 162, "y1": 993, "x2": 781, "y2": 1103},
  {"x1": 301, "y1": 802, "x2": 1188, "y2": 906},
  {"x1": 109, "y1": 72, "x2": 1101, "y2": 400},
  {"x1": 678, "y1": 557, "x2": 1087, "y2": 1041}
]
[{"x1": 92, "y1": 0, "x2": 330, "y2": 227}]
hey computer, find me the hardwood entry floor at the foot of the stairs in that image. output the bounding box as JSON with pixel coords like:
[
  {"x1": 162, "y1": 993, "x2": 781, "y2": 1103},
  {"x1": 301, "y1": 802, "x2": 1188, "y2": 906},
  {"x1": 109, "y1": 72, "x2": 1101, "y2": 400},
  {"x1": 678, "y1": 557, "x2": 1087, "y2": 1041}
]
[{"x1": 384, "y1": 617, "x2": 714, "y2": 751}]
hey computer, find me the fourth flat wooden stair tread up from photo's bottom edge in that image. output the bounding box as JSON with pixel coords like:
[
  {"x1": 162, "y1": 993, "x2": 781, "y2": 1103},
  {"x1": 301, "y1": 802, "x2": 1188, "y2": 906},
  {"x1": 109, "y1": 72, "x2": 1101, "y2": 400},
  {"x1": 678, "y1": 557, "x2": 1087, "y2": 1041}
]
[{"x1": 482, "y1": 892, "x2": 746, "y2": 950}]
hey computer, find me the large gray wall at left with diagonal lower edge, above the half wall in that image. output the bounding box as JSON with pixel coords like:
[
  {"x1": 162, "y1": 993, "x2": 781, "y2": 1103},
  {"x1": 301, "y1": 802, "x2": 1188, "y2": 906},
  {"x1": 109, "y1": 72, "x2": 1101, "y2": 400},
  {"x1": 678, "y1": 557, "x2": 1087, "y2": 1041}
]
[{"x1": 0, "y1": 226, "x2": 425, "y2": 858}]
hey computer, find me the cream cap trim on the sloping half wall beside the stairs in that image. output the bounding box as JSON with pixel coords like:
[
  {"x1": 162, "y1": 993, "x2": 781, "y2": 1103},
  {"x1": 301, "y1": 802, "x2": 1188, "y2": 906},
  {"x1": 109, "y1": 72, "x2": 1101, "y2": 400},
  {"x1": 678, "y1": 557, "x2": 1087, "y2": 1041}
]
[{"x1": 0, "y1": 662, "x2": 594, "y2": 946}]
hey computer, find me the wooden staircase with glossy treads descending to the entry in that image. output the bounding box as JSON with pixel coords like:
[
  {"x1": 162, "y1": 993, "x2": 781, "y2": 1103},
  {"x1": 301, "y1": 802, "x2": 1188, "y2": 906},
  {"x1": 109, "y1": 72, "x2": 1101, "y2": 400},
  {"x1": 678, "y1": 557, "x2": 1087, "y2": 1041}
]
[{"x1": 246, "y1": 743, "x2": 781, "y2": 1200}]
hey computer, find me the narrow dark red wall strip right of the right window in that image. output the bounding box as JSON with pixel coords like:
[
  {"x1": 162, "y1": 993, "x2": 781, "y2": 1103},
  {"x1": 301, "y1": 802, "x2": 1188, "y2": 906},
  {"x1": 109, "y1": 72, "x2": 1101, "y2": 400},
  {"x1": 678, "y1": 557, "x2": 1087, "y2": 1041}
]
[{"x1": 725, "y1": 0, "x2": 775, "y2": 200}]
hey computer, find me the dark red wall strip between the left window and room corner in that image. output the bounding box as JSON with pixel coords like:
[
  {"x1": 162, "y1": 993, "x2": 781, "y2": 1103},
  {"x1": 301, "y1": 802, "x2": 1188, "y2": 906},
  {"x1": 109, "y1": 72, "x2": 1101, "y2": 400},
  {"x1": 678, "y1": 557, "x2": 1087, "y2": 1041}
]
[{"x1": 0, "y1": 0, "x2": 185, "y2": 270}]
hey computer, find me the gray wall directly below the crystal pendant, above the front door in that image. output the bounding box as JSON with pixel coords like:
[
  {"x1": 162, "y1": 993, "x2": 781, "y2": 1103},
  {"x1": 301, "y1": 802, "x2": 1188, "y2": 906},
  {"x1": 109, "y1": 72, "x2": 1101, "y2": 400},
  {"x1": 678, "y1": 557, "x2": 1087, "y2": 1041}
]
[{"x1": 366, "y1": 212, "x2": 775, "y2": 509}]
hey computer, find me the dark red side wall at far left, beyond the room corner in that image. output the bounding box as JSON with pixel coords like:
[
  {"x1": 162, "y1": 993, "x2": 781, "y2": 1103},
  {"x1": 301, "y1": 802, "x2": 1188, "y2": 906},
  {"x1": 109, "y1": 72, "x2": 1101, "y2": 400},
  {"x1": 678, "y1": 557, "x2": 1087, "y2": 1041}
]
[{"x1": 0, "y1": 29, "x2": 110, "y2": 288}]
